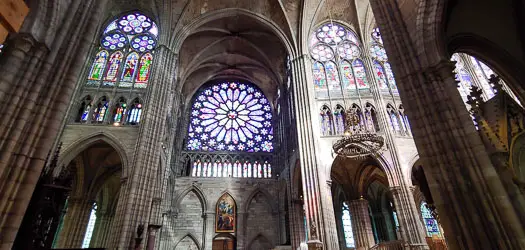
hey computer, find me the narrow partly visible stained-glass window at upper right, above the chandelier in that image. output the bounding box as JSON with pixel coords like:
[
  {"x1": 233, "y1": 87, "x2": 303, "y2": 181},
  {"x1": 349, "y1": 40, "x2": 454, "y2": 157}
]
[{"x1": 370, "y1": 28, "x2": 397, "y2": 90}]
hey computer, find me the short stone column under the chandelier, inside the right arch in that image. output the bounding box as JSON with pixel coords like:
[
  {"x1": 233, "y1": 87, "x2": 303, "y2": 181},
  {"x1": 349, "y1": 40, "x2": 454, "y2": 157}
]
[{"x1": 348, "y1": 198, "x2": 375, "y2": 250}]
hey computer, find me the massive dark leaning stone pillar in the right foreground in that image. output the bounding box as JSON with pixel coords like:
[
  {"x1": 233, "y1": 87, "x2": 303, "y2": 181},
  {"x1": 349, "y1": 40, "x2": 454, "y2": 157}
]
[{"x1": 370, "y1": 0, "x2": 525, "y2": 249}]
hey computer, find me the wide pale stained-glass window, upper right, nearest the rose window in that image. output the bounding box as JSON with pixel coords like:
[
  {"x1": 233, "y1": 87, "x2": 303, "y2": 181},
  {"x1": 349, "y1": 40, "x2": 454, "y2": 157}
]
[{"x1": 310, "y1": 23, "x2": 368, "y2": 99}]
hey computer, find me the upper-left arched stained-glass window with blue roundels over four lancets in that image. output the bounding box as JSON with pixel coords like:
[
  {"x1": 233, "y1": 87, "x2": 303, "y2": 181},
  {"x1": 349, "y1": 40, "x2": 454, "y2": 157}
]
[{"x1": 87, "y1": 12, "x2": 158, "y2": 88}]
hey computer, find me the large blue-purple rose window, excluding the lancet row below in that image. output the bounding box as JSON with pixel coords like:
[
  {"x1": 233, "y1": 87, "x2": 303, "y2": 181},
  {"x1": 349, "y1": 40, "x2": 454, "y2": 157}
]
[{"x1": 186, "y1": 82, "x2": 273, "y2": 152}]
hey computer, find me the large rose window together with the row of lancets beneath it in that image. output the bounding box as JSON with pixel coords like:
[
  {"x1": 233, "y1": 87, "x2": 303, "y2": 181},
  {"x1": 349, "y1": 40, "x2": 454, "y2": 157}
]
[{"x1": 185, "y1": 82, "x2": 274, "y2": 178}]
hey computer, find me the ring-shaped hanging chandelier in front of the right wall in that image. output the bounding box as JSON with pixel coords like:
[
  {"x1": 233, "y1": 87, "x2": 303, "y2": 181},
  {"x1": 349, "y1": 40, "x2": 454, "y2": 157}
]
[{"x1": 332, "y1": 108, "x2": 385, "y2": 159}]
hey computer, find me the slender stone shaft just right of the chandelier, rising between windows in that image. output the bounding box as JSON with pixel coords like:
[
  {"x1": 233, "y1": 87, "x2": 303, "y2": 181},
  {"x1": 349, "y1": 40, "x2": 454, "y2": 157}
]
[{"x1": 363, "y1": 56, "x2": 426, "y2": 247}]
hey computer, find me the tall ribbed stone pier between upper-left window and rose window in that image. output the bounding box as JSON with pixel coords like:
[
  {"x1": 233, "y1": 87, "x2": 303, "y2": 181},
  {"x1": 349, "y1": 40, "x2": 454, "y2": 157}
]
[{"x1": 119, "y1": 45, "x2": 177, "y2": 248}]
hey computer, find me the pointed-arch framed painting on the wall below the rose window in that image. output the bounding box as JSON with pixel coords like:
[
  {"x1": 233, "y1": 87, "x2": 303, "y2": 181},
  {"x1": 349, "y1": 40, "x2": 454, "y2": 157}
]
[{"x1": 215, "y1": 194, "x2": 236, "y2": 233}]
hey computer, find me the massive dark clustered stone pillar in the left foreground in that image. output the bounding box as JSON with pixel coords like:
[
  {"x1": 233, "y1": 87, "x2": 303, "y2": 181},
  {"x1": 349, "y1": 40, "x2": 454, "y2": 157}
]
[{"x1": 0, "y1": 0, "x2": 107, "y2": 249}]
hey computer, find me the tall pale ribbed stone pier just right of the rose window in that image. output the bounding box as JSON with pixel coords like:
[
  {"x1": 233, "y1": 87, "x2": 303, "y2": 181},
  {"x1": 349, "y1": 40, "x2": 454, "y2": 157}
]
[{"x1": 292, "y1": 55, "x2": 324, "y2": 248}]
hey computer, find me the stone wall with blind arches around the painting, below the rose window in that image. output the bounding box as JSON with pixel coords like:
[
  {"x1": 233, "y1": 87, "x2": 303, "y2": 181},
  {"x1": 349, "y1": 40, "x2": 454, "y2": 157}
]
[{"x1": 167, "y1": 177, "x2": 285, "y2": 249}]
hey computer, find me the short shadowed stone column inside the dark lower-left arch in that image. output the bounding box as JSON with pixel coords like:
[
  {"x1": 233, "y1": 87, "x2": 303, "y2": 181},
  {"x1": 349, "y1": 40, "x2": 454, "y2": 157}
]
[{"x1": 57, "y1": 198, "x2": 93, "y2": 248}]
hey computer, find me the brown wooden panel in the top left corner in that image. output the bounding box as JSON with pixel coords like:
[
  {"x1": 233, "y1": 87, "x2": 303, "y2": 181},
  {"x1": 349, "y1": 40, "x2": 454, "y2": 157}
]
[{"x1": 0, "y1": 0, "x2": 29, "y2": 32}]
